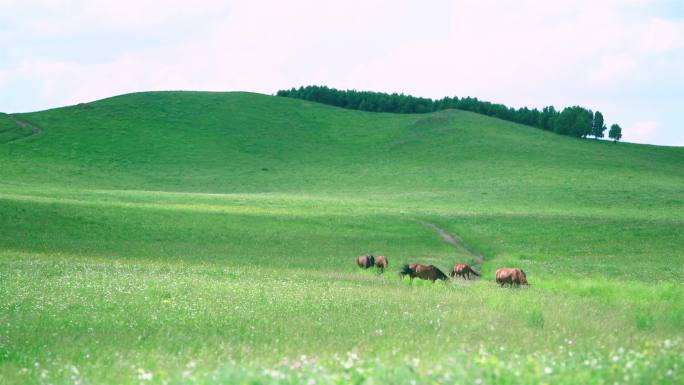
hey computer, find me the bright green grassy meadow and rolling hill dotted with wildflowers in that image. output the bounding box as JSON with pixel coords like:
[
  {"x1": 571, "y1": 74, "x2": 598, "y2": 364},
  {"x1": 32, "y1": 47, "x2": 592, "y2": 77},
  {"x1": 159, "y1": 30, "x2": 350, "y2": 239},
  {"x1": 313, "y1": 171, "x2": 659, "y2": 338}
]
[{"x1": 0, "y1": 92, "x2": 684, "y2": 385}]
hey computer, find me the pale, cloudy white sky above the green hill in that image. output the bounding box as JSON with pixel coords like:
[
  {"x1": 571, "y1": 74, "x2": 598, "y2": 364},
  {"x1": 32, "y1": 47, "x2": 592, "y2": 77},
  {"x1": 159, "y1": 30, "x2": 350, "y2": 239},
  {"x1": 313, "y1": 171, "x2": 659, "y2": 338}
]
[{"x1": 0, "y1": 0, "x2": 684, "y2": 146}]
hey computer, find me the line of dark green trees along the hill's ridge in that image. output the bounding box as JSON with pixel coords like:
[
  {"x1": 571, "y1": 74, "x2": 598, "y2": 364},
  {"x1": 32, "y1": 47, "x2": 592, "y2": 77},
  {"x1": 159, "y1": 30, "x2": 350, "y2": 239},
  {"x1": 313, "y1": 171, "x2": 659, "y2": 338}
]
[{"x1": 276, "y1": 86, "x2": 622, "y2": 141}]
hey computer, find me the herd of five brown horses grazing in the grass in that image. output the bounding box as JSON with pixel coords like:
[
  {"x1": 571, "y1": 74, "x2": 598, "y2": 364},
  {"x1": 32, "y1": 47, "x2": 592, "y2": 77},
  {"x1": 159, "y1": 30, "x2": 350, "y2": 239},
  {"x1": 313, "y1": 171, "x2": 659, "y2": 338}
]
[{"x1": 356, "y1": 255, "x2": 529, "y2": 287}]
